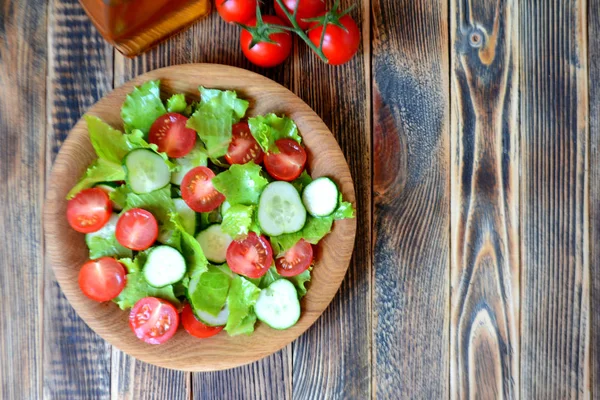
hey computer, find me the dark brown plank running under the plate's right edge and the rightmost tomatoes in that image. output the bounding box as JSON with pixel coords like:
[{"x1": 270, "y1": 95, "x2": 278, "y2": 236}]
[{"x1": 292, "y1": 0, "x2": 371, "y2": 400}]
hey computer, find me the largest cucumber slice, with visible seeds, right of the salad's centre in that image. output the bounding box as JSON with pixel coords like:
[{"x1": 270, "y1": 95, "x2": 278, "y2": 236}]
[{"x1": 258, "y1": 181, "x2": 306, "y2": 236}]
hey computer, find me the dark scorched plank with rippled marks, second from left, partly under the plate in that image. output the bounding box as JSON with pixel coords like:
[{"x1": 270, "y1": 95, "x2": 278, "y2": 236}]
[{"x1": 40, "y1": 0, "x2": 113, "y2": 399}]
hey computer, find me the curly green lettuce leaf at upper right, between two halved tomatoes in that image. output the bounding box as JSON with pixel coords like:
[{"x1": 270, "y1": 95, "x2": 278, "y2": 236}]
[{"x1": 248, "y1": 114, "x2": 302, "y2": 153}]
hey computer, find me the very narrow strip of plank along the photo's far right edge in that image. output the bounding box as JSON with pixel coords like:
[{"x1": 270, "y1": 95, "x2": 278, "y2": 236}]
[{"x1": 588, "y1": 0, "x2": 600, "y2": 398}]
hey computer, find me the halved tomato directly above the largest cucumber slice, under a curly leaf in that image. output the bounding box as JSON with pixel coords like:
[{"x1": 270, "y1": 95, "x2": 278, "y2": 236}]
[{"x1": 265, "y1": 139, "x2": 306, "y2": 182}]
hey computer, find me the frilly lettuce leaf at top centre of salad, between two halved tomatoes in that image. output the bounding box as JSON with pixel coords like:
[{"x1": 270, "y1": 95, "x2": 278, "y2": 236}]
[{"x1": 187, "y1": 87, "x2": 249, "y2": 158}]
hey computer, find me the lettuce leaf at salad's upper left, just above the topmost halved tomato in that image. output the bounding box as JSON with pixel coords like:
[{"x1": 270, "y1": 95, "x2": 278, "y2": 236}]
[{"x1": 121, "y1": 80, "x2": 167, "y2": 135}]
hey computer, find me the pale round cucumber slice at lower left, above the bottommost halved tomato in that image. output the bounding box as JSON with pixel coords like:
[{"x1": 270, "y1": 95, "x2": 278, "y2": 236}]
[{"x1": 143, "y1": 246, "x2": 187, "y2": 287}]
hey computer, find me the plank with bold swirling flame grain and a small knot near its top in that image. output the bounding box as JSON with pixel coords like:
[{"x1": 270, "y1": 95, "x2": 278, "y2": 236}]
[{"x1": 450, "y1": 0, "x2": 519, "y2": 399}]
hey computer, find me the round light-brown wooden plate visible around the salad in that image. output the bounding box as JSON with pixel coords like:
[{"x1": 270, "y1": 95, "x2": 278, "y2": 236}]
[{"x1": 44, "y1": 64, "x2": 356, "y2": 371}]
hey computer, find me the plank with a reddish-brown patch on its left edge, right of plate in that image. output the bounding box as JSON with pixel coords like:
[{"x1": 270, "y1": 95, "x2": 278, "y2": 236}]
[{"x1": 372, "y1": 0, "x2": 450, "y2": 399}]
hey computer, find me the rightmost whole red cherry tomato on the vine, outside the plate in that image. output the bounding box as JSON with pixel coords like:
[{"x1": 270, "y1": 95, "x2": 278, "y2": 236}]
[{"x1": 308, "y1": 15, "x2": 360, "y2": 65}]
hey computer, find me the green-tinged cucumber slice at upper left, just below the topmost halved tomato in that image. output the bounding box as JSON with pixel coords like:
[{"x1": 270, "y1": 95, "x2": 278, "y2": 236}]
[{"x1": 124, "y1": 149, "x2": 171, "y2": 193}]
